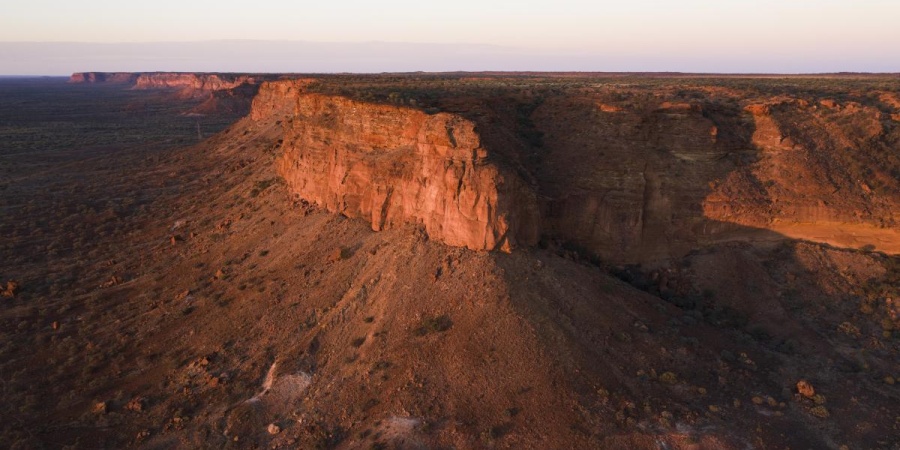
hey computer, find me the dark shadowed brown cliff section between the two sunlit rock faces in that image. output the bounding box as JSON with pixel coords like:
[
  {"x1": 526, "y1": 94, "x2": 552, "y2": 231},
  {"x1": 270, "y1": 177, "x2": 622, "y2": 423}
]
[{"x1": 533, "y1": 97, "x2": 735, "y2": 262}]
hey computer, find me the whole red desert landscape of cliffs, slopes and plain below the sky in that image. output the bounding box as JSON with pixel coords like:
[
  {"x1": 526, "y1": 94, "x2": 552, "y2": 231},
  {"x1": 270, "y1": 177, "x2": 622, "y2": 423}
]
[{"x1": 0, "y1": 72, "x2": 900, "y2": 449}]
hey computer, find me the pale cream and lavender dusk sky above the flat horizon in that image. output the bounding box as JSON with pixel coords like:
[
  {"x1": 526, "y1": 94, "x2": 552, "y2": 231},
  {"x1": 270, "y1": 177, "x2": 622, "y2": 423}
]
[{"x1": 0, "y1": 0, "x2": 900, "y2": 75}]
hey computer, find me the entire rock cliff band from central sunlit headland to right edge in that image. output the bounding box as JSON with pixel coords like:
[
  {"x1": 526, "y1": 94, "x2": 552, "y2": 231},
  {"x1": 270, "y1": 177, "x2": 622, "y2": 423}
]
[{"x1": 251, "y1": 80, "x2": 900, "y2": 263}]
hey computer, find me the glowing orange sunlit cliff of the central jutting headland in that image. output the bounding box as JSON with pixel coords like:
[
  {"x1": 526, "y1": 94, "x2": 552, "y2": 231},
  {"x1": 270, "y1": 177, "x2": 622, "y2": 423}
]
[{"x1": 251, "y1": 81, "x2": 539, "y2": 251}]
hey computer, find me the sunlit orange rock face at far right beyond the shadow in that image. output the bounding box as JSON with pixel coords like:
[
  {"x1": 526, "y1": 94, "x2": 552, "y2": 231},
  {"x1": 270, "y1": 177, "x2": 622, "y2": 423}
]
[{"x1": 705, "y1": 99, "x2": 900, "y2": 225}]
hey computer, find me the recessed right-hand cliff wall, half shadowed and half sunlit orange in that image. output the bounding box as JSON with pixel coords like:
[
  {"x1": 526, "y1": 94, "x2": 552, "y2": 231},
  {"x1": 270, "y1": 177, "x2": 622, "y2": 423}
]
[{"x1": 531, "y1": 90, "x2": 900, "y2": 262}]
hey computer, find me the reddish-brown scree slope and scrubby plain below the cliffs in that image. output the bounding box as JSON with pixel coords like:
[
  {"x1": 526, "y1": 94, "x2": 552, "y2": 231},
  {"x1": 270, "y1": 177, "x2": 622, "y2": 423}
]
[{"x1": 0, "y1": 75, "x2": 900, "y2": 449}]
